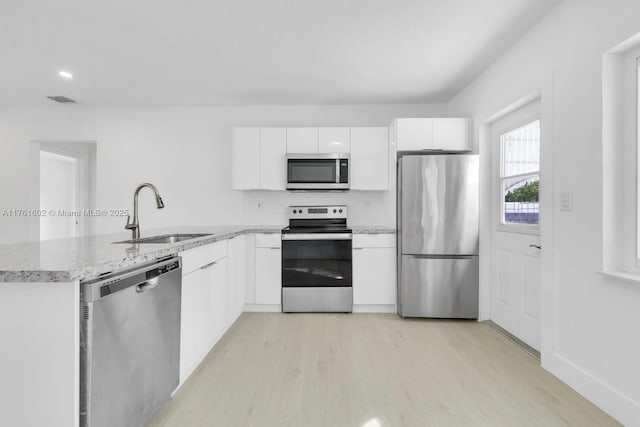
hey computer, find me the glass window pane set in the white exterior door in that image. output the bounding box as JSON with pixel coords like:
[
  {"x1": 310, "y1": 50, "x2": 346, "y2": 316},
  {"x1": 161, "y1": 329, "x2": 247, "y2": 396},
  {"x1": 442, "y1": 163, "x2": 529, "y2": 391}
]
[{"x1": 500, "y1": 119, "x2": 540, "y2": 225}]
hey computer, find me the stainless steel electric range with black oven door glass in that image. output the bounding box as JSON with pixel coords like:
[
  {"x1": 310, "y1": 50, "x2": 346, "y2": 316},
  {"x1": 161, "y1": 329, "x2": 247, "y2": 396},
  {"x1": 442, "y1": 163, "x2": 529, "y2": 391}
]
[{"x1": 282, "y1": 206, "x2": 353, "y2": 313}]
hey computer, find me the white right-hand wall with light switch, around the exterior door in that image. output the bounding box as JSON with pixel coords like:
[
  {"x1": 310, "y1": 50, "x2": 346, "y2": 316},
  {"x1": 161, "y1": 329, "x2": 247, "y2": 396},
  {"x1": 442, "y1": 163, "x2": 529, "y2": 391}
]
[{"x1": 447, "y1": 0, "x2": 640, "y2": 425}]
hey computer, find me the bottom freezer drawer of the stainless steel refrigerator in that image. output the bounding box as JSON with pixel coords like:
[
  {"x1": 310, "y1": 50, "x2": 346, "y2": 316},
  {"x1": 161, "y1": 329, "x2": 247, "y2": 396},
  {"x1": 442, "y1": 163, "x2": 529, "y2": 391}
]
[{"x1": 398, "y1": 255, "x2": 479, "y2": 319}]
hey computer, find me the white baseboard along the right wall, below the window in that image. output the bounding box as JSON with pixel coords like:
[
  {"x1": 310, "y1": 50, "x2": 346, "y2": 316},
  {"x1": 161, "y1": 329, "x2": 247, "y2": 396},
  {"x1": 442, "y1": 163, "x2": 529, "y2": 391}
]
[{"x1": 542, "y1": 353, "x2": 640, "y2": 427}]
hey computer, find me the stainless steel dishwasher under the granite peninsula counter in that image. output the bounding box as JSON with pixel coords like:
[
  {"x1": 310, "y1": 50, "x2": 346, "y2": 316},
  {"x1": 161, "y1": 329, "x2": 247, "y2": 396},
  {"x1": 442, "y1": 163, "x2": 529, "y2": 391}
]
[{"x1": 80, "y1": 257, "x2": 182, "y2": 427}]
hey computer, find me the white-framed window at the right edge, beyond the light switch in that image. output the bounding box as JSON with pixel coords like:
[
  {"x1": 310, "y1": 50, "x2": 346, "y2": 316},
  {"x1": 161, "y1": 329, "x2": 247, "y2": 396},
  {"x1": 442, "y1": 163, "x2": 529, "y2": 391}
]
[{"x1": 602, "y1": 33, "x2": 640, "y2": 282}]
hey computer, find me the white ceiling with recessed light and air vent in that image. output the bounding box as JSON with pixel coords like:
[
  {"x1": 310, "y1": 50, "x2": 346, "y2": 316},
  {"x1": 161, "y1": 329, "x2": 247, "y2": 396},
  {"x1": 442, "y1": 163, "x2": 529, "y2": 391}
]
[{"x1": 0, "y1": 0, "x2": 560, "y2": 105}]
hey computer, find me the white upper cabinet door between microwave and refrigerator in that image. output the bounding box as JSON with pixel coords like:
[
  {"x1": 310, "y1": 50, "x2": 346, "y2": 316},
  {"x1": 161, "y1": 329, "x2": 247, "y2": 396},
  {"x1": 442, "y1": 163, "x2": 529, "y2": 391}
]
[{"x1": 350, "y1": 127, "x2": 389, "y2": 190}]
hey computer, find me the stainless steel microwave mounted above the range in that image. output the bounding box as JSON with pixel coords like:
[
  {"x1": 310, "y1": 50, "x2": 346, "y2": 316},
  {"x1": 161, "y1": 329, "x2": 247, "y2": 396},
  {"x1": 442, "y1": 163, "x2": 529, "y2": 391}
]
[{"x1": 287, "y1": 153, "x2": 349, "y2": 191}]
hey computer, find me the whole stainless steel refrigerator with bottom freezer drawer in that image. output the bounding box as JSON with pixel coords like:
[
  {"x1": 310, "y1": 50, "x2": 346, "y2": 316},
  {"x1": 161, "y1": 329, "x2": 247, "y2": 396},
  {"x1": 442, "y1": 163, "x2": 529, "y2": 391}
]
[{"x1": 397, "y1": 154, "x2": 479, "y2": 319}]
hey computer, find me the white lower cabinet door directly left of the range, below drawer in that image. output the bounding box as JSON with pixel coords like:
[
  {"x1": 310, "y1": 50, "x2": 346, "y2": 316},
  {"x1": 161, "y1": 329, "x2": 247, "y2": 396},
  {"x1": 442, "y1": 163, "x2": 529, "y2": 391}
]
[{"x1": 256, "y1": 247, "x2": 282, "y2": 304}]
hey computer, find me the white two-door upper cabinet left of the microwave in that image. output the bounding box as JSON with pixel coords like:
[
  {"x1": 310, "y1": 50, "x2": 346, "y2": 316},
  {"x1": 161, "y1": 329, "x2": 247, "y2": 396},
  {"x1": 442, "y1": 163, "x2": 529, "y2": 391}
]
[{"x1": 233, "y1": 127, "x2": 287, "y2": 190}]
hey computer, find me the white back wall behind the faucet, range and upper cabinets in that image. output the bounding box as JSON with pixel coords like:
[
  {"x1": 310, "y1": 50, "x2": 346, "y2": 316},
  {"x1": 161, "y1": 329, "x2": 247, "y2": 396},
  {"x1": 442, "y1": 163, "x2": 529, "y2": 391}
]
[{"x1": 0, "y1": 104, "x2": 444, "y2": 243}]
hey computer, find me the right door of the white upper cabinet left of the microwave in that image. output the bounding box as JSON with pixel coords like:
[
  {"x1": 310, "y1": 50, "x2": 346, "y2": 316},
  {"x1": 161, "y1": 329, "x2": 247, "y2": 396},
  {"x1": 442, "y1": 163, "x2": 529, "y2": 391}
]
[{"x1": 260, "y1": 128, "x2": 287, "y2": 190}]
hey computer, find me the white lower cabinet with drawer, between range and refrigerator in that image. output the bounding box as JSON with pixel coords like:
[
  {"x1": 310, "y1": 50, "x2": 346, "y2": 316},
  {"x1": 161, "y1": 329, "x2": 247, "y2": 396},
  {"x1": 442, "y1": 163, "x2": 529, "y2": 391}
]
[{"x1": 353, "y1": 234, "x2": 396, "y2": 305}]
